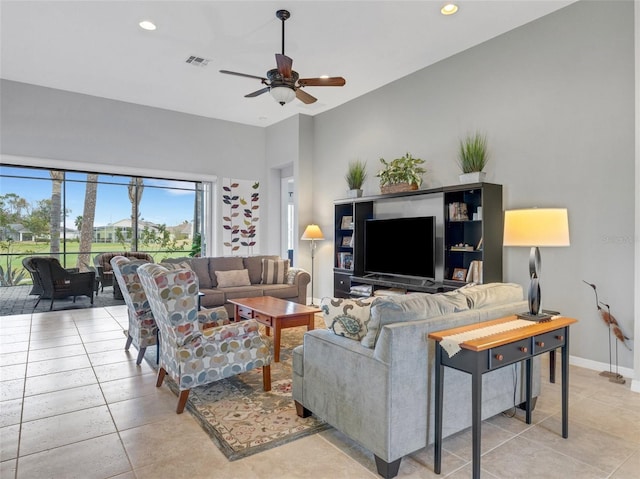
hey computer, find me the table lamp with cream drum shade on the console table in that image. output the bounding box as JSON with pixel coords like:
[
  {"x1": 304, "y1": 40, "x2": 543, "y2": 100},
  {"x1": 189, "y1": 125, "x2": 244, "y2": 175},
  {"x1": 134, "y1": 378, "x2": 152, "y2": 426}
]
[{"x1": 503, "y1": 208, "x2": 570, "y2": 321}]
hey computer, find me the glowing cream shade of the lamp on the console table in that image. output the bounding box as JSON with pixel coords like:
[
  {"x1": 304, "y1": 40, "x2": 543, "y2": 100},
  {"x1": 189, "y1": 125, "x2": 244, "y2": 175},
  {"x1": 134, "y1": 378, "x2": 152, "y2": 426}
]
[{"x1": 503, "y1": 208, "x2": 570, "y2": 247}]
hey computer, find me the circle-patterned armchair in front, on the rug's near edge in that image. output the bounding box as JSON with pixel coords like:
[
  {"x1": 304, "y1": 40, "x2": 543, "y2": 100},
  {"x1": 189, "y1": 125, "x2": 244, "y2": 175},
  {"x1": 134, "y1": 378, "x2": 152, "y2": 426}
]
[{"x1": 138, "y1": 263, "x2": 271, "y2": 414}]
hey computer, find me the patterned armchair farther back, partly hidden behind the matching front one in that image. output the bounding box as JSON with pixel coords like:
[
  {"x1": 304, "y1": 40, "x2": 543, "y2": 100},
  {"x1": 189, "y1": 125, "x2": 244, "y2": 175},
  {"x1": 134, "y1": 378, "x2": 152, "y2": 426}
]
[{"x1": 111, "y1": 256, "x2": 160, "y2": 364}]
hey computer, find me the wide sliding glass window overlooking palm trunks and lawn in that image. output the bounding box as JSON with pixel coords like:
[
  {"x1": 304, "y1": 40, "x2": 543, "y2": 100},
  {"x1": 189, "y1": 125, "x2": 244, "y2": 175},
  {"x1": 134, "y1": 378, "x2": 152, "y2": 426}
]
[{"x1": 0, "y1": 165, "x2": 210, "y2": 286}]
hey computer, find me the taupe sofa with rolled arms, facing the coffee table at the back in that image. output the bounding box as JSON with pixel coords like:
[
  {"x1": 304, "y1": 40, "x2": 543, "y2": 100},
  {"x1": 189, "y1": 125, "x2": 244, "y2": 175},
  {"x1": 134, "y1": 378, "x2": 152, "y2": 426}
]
[{"x1": 165, "y1": 255, "x2": 311, "y2": 318}]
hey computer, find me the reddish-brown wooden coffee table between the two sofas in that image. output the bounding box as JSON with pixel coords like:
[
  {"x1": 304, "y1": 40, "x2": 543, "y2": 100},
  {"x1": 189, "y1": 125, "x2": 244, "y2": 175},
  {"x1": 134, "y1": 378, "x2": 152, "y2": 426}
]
[{"x1": 227, "y1": 296, "x2": 322, "y2": 363}]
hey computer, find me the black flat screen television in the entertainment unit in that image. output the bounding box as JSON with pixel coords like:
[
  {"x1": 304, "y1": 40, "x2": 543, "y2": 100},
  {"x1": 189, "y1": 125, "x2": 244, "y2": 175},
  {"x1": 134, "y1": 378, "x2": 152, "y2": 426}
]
[{"x1": 364, "y1": 216, "x2": 436, "y2": 280}]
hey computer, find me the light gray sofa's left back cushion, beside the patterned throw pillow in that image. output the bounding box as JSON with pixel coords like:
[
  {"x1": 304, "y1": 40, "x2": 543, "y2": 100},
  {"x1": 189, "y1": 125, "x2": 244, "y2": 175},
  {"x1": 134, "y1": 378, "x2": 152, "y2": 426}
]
[{"x1": 361, "y1": 291, "x2": 469, "y2": 348}]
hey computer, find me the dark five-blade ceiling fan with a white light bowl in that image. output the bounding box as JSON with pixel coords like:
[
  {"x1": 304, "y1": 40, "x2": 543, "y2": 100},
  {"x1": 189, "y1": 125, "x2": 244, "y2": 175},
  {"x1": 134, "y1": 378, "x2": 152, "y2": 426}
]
[{"x1": 220, "y1": 10, "x2": 346, "y2": 105}]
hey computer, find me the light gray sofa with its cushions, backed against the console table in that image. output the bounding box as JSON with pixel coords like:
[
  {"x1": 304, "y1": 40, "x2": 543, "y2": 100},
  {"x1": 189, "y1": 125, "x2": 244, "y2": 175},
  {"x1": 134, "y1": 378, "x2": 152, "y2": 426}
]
[{"x1": 293, "y1": 283, "x2": 540, "y2": 477}]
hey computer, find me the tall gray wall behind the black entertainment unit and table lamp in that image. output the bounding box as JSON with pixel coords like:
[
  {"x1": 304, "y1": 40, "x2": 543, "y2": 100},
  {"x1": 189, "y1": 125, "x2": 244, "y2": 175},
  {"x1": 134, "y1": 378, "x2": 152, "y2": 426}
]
[{"x1": 313, "y1": 1, "x2": 635, "y2": 367}]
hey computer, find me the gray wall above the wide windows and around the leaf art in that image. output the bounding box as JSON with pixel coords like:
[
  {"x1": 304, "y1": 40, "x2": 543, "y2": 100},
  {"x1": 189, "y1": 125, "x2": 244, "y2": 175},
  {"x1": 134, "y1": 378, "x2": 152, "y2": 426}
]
[{"x1": 0, "y1": 80, "x2": 270, "y2": 253}]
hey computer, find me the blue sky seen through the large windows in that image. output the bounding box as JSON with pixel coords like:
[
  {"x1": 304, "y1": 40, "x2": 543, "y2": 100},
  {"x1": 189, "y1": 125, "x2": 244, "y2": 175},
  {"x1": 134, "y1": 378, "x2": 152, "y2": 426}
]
[{"x1": 0, "y1": 165, "x2": 199, "y2": 228}]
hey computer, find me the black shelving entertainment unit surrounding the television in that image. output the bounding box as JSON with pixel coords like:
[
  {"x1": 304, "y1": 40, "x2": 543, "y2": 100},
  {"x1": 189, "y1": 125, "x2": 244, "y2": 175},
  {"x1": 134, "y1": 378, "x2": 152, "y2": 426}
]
[{"x1": 333, "y1": 183, "x2": 503, "y2": 298}]
